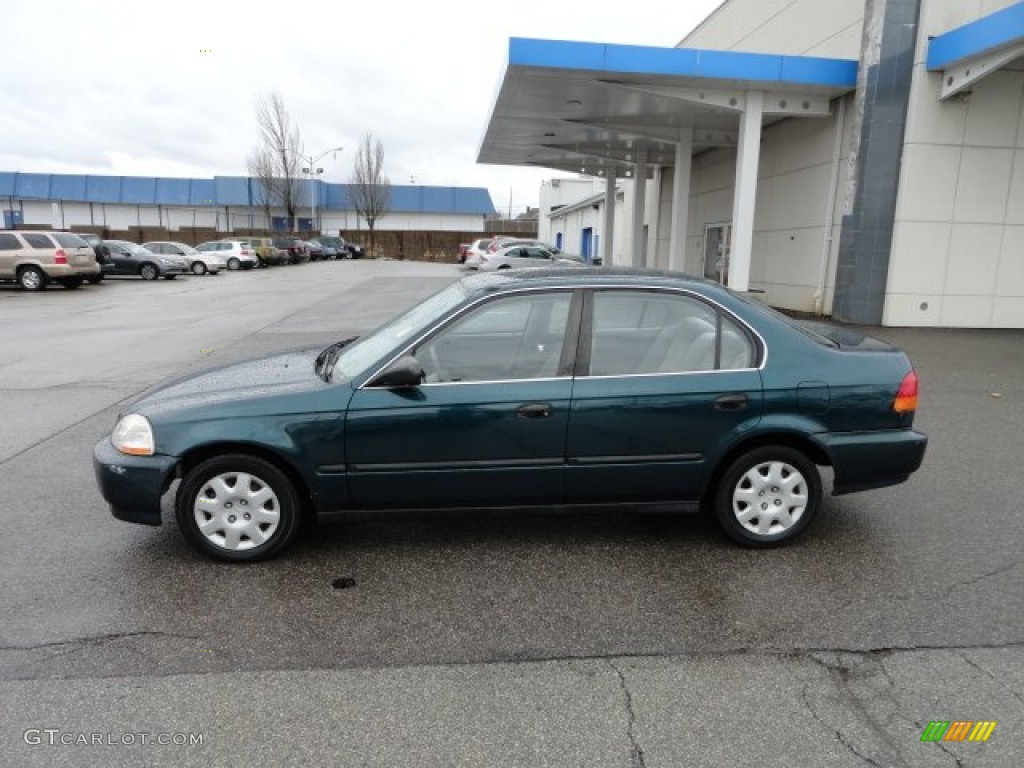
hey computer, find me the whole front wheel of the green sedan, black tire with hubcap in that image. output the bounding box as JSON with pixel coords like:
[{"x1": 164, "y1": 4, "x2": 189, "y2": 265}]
[{"x1": 175, "y1": 454, "x2": 301, "y2": 562}]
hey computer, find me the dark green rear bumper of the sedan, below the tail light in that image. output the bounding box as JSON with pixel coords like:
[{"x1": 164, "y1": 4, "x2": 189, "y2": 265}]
[{"x1": 816, "y1": 429, "x2": 928, "y2": 496}]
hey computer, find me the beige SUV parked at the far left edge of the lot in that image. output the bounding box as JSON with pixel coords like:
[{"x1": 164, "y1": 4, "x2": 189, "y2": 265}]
[{"x1": 0, "y1": 229, "x2": 99, "y2": 291}]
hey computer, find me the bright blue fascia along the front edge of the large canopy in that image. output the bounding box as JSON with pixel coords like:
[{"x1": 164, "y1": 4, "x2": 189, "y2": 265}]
[{"x1": 509, "y1": 38, "x2": 857, "y2": 88}]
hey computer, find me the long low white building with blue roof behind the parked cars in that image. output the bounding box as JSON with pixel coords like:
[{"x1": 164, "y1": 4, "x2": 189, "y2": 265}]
[{"x1": 0, "y1": 172, "x2": 495, "y2": 233}]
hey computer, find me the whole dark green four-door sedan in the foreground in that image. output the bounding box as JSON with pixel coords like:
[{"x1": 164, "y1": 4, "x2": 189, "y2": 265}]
[{"x1": 93, "y1": 269, "x2": 928, "y2": 560}]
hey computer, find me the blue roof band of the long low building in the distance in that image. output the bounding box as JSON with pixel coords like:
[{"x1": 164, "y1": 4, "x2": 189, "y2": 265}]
[{"x1": 0, "y1": 171, "x2": 495, "y2": 215}]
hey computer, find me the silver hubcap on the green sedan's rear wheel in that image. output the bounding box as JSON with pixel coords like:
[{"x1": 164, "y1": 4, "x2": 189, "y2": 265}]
[{"x1": 732, "y1": 462, "x2": 808, "y2": 536}]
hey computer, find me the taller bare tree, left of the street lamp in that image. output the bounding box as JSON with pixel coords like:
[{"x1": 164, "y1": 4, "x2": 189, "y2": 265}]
[{"x1": 250, "y1": 92, "x2": 302, "y2": 231}]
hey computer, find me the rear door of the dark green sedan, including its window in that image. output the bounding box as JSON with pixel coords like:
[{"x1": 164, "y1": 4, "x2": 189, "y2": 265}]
[{"x1": 565, "y1": 289, "x2": 762, "y2": 503}]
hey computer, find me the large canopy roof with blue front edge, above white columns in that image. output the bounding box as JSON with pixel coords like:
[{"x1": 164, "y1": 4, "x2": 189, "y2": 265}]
[{"x1": 477, "y1": 38, "x2": 857, "y2": 177}]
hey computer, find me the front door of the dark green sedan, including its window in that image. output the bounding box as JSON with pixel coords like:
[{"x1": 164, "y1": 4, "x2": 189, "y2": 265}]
[{"x1": 345, "y1": 290, "x2": 580, "y2": 508}]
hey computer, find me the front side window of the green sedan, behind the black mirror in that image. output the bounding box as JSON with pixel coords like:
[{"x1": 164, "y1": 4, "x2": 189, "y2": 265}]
[{"x1": 414, "y1": 291, "x2": 571, "y2": 384}]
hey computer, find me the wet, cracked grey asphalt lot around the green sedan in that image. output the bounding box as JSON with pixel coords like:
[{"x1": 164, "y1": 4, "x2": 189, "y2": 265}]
[{"x1": 0, "y1": 262, "x2": 1024, "y2": 768}]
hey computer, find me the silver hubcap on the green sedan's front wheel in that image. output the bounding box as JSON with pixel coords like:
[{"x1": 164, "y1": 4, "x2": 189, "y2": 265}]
[{"x1": 193, "y1": 472, "x2": 281, "y2": 551}]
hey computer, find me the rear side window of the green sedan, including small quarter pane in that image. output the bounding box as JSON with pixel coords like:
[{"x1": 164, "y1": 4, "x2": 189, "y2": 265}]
[{"x1": 590, "y1": 291, "x2": 756, "y2": 376}]
